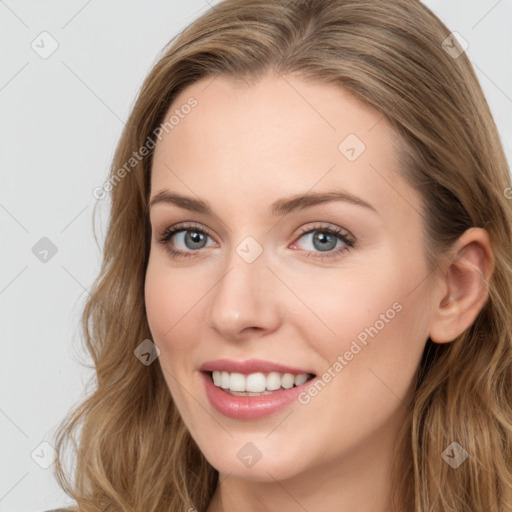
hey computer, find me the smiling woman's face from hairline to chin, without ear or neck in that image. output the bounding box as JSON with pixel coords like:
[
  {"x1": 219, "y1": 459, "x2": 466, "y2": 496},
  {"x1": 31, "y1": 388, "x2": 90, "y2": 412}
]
[{"x1": 145, "y1": 75, "x2": 433, "y2": 481}]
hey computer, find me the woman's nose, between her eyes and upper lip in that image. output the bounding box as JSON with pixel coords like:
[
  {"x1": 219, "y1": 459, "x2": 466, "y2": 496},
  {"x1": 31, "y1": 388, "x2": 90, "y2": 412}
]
[{"x1": 206, "y1": 245, "x2": 283, "y2": 341}]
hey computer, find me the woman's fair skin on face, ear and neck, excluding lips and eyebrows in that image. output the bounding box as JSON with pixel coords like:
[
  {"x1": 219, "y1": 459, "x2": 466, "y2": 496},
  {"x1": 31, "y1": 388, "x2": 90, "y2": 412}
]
[{"x1": 145, "y1": 74, "x2": 493, "y2": 512}]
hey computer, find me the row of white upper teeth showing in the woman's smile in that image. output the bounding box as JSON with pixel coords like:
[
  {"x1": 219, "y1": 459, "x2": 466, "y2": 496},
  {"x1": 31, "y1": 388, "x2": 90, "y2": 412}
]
[{"x1": 212, "y1": 370, "x2": 309, "y2": 396}]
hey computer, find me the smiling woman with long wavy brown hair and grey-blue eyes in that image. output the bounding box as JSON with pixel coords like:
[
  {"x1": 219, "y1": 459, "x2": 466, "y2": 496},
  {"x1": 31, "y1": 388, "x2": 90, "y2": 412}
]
[{"x1": 51, "y1": 0, "x2": 512, "y2": 512}]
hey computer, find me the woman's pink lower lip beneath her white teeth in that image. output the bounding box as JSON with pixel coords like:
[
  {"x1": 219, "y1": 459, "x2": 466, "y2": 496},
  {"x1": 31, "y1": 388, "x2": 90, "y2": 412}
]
[{"x1": 201, "y1": 372, "x2": 314, "y2": 420}]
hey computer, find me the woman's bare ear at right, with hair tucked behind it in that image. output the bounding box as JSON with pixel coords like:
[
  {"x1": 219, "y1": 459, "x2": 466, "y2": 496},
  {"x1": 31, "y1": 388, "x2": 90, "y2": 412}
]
[{"x1": 430, "y1": 228, "x2": 494, "y2": 343}]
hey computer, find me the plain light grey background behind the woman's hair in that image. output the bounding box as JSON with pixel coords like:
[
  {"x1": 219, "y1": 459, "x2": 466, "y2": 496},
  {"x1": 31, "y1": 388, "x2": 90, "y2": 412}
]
[{"x1": 0, "y1": 0, "x2": 512, "y2": 512}]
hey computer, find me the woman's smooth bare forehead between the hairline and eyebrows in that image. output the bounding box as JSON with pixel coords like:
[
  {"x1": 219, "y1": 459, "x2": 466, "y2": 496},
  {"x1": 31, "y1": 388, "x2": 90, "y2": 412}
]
[{"x1": 151, "y1": 74, "x2": 419, "y2": 224}]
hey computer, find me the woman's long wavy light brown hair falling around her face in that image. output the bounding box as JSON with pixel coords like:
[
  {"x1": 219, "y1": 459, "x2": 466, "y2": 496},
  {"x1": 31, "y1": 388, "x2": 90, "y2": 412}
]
[{"x1": 51, "y1": 0, "x2": 512, "y2": 512}]
